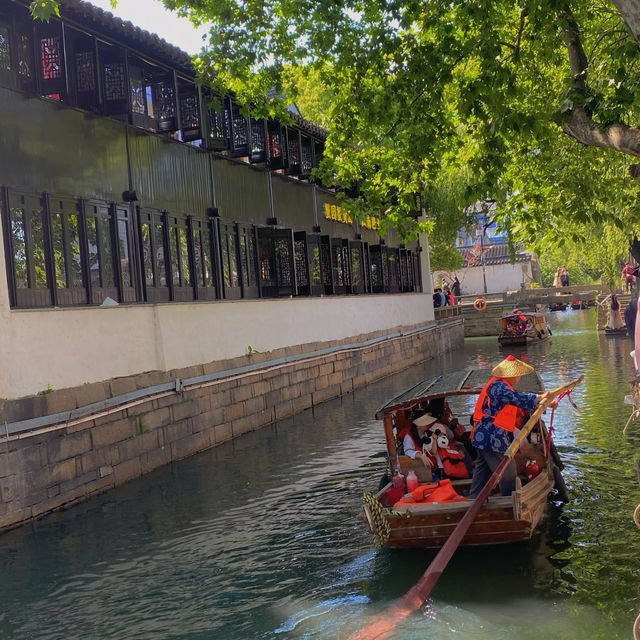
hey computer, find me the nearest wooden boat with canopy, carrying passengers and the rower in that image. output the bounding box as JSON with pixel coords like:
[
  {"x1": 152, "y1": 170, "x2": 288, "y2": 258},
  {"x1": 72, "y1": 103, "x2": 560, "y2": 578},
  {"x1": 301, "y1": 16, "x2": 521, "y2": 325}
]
[{"x1": 363, "y1": 369, "x2": 566, "y2": 548}]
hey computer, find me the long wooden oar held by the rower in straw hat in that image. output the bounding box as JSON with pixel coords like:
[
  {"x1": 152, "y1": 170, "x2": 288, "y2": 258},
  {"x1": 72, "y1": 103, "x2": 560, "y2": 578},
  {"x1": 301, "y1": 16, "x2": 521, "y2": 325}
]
[{"x1": 348, "y1": 376, "x2": 584, "y2": 640}]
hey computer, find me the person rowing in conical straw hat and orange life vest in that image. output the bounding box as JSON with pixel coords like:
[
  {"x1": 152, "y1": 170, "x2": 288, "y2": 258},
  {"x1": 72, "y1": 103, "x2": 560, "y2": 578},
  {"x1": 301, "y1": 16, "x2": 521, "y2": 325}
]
[{"x1": 469, "y1": 356, "x2": 554, "y2": 498}]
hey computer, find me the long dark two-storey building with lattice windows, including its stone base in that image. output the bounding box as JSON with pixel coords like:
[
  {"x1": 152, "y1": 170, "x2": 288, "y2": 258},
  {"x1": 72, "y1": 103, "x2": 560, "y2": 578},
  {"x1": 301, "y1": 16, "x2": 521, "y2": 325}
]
[{"x1": 0, "y1": 0, "x2": 462, "y2": 529}]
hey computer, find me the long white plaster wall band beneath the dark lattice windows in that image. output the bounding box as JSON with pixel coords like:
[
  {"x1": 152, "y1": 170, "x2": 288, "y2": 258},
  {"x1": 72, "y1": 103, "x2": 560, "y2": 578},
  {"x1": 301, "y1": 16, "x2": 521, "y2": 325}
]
[{"x1": 0, "y1": 292, "x2": 434, "y2": 399}]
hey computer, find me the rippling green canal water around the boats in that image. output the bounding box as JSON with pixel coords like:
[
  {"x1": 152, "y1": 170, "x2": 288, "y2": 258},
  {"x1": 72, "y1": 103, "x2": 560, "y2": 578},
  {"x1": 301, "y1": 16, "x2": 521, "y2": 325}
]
[{"x1": 0, "y1": 309, "x2": 640, "y2": 640}]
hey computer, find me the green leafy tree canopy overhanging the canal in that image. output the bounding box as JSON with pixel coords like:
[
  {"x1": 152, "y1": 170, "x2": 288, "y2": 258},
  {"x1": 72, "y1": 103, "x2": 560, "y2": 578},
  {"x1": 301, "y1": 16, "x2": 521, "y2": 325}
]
[{"x1": 32, "y1": 0, "x2": 640, "y2": 258}]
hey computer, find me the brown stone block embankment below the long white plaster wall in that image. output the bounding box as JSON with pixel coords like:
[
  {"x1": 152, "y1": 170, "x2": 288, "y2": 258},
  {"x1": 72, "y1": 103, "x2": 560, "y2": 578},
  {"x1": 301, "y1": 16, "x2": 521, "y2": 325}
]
[{"x1": 0, "y1": 318, "x2": 463, "y2": 530}]
